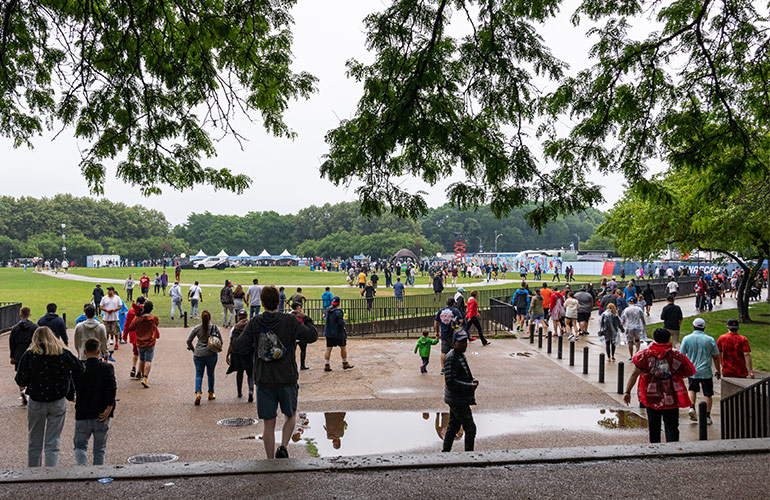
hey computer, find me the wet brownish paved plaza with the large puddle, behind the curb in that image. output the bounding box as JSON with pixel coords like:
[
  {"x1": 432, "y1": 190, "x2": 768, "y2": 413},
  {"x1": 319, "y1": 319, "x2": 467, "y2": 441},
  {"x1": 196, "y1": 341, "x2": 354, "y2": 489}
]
[{"x1": 0, "y1": 299, "x2": 732, "y2": 467}]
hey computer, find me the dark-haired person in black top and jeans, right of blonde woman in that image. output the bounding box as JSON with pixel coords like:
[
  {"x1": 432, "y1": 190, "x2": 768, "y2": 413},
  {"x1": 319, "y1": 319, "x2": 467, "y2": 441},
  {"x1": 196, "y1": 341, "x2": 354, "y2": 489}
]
[{"x1": 72, "y1": 338, "x2": 118, "y2": 466}]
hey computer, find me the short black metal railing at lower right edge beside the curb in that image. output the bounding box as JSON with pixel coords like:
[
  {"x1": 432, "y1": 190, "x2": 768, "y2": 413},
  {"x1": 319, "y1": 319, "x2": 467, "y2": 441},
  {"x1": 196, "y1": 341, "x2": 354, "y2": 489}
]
[{"x1": 719, "y1": 378, "x2": 770, "y2": 439}]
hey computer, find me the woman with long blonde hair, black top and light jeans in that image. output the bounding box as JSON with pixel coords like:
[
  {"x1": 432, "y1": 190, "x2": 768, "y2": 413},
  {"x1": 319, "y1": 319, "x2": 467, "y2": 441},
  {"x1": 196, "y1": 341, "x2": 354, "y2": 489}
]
[{"x1": 16, "y1": 326, "x2": 83, "y2": 467}]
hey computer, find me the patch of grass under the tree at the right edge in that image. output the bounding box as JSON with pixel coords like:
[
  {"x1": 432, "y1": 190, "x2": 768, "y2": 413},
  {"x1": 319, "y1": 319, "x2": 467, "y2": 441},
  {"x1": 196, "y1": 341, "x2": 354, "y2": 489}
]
[{"x1": 647, "y1": 302, "x2": 770, "y2": 371}]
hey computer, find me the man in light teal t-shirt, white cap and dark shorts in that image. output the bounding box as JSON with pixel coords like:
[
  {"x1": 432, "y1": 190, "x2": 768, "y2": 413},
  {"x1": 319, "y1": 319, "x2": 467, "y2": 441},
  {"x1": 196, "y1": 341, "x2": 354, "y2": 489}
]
[{"x1": 680, "y1": 318, "x2": 721, "y2": 425}]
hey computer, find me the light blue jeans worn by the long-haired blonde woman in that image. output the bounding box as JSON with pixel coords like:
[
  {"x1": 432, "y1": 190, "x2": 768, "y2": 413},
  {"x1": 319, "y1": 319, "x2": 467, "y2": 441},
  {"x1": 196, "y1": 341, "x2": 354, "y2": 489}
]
[{"x1": 27, "y1": 398, "x2": 67, "y2": 467}]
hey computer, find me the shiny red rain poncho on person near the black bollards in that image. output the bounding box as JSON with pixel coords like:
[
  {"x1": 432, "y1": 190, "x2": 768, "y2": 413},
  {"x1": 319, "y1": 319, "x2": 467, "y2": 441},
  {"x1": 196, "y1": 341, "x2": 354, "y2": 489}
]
[{"x1": 632, "y1": 342, "x2": 695, "y2": 410}]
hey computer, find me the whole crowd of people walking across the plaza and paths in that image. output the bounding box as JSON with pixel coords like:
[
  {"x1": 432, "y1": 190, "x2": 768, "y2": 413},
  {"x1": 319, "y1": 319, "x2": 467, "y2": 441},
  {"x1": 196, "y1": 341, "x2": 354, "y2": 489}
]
[{"x1": 4, "y1": 265, "x2": 754, "y2": 467}]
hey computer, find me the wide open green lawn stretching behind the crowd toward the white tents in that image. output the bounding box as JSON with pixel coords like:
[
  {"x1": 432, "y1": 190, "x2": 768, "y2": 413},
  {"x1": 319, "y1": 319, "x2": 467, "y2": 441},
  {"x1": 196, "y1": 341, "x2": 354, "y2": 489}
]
[{"x1": 0, "y1": 267, "x2": 608, "y2": 328}]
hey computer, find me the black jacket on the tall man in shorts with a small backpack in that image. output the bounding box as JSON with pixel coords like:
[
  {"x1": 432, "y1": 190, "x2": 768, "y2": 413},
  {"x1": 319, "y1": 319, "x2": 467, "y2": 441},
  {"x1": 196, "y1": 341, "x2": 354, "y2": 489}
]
[{"x1": 232, "y1": 312, "x2": 318, "y2": 387}]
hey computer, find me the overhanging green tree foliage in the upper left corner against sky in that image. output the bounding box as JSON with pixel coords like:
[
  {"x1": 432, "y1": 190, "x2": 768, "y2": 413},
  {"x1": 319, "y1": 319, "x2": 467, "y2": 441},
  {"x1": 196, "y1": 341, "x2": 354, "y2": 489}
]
[{"x1": 0, "y1": 0, "x2": 315, "y2": 194}]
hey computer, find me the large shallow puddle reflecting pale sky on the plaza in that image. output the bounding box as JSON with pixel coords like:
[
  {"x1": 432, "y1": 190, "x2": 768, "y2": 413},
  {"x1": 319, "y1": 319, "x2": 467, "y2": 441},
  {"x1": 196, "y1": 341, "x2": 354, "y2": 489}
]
[{"x1": 278, "y1": 408, "x2": 647, "y2": 457}]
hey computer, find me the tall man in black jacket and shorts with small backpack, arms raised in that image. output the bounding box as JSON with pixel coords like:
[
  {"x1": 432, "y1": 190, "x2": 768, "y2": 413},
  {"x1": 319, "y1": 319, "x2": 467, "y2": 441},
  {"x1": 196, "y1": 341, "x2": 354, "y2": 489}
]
[{"x1": 233, "y1": 286, "x2": 318, "y2": 459}]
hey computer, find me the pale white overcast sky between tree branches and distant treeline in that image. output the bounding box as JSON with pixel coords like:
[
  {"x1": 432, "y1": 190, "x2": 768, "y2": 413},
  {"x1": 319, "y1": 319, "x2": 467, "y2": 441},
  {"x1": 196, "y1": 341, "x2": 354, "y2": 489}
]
[{"x1": 0, "y1": 0, "x2": 648, "y2": 224}]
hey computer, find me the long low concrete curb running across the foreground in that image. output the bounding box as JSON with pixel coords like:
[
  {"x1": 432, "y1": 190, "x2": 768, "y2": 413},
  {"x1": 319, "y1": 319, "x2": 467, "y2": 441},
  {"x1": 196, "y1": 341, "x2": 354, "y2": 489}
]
[{"x1": 0, "y1": 438, "x2": 770, "y2": 484}]
